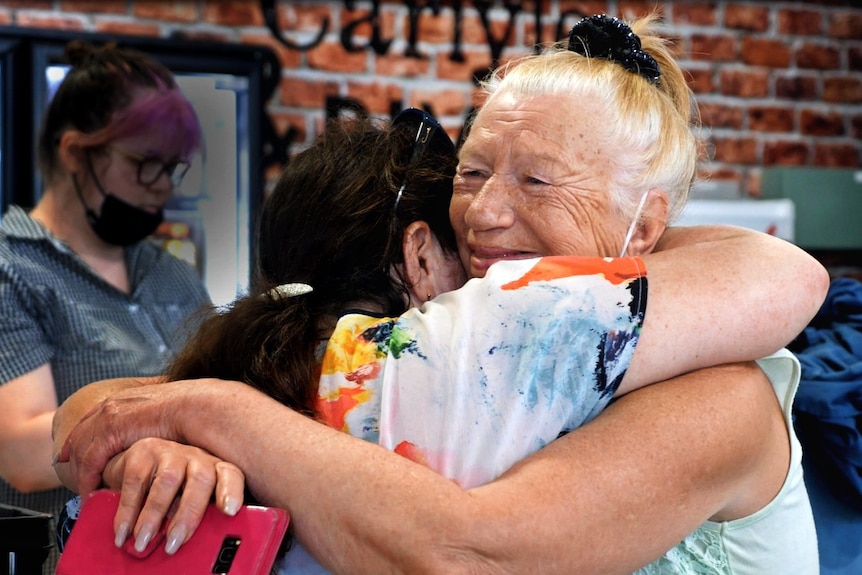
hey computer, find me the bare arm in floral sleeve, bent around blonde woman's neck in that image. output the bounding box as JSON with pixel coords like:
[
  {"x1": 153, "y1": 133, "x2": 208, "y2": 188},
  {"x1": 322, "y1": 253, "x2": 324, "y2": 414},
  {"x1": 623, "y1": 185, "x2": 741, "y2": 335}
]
[{"x1": 618, "y1": 226, "x2": 829, "y2": 395}]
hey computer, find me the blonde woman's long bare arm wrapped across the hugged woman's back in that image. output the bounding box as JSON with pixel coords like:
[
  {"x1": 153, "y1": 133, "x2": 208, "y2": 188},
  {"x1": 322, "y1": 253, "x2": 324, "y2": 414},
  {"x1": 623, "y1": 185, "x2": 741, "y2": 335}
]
[{"x1": 59, "y1": 365, "x2": 787, "y2": 574}]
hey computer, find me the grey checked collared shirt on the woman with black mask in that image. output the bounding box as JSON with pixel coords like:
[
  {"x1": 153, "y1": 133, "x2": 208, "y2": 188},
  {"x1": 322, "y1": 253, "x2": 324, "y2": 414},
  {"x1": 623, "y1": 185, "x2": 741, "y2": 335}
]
[{"x1": 0, "y1": 206, "x2": 210, "y2": 514}]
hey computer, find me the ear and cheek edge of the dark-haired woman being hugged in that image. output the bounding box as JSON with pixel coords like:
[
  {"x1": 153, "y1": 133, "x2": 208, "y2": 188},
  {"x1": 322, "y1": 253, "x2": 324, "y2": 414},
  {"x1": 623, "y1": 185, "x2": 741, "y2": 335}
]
[{"x1": 402, "y1": 221, "x2": 466, "y2": 306}]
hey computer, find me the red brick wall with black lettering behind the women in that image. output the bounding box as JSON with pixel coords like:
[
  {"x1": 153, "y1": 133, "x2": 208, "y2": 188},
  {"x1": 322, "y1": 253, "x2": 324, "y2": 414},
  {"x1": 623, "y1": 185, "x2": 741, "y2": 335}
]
[{"x1": 0, "y1": 0, "x2": 862, "y2": 195}]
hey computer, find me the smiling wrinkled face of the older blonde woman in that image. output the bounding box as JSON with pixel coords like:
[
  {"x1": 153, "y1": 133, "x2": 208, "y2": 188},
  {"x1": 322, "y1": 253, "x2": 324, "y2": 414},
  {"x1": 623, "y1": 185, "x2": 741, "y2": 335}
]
[{"x1": 449, "y1": 94, "x2": 629, "y2": 277}]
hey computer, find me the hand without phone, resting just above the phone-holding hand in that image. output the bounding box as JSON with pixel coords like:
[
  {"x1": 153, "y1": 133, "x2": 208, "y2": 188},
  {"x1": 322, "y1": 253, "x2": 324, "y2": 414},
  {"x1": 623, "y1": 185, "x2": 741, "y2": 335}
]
[{"x1": 54, "y1": 381, "x2": 198, "y2": 496}]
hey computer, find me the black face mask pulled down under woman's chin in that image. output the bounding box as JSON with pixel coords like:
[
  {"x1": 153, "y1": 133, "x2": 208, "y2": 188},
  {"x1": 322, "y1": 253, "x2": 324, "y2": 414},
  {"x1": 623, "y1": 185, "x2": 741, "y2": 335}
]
[{"x1": 72, "y1": 166, "x2": 165, "y2": 247}]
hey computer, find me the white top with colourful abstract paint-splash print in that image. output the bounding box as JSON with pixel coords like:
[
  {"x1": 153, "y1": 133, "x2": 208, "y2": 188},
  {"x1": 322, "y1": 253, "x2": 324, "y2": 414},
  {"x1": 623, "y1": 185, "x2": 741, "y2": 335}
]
[{"x1": 318, "y1": 257, "x2": 647, "y2": 488}]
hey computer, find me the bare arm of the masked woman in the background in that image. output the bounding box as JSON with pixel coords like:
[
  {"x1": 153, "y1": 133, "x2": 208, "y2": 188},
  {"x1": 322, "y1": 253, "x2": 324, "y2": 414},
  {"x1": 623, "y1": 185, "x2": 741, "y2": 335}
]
[{"x1": 0, "y1": 364, "x2": 61, "y2": 493}]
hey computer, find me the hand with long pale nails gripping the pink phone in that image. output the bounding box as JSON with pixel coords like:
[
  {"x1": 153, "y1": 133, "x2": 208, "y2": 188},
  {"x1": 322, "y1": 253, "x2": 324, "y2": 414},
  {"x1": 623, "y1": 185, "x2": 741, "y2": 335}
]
[{"x1": 103, "y1": 438, "x2": 245, "y2": 554}]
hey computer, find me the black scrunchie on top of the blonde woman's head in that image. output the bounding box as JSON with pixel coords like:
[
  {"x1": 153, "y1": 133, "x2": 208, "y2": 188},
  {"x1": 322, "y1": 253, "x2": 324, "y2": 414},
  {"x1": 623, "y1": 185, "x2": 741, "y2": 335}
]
[{"x1": 568, "y1": 14, "x2": 661, "y2": 85}]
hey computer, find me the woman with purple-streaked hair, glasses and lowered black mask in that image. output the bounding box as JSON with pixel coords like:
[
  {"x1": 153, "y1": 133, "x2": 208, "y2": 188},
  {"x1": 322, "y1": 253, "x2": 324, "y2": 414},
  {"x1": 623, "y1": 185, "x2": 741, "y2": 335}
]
[{"x1": 0, "y1": 42, "x2": 209, "y2": 572}]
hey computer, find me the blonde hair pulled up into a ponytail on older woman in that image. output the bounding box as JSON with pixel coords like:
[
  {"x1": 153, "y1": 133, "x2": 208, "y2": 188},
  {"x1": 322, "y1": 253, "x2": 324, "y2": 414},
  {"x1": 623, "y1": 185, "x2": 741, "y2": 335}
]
[{"x1": 482, "y1": 15, "x2": 700, "y2": 223}]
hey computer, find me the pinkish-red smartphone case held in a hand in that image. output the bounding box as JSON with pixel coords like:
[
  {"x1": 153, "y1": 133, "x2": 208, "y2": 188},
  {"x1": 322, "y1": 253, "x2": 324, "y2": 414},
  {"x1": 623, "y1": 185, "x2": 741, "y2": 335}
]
[{"x1": 55, "y1": 490, "x2": 289, "y2": 575}]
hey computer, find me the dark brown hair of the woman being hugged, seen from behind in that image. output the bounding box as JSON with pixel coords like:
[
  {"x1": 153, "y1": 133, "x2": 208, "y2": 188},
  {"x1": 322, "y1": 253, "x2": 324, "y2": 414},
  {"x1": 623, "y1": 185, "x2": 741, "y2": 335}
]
[{"x1": 168, "y1": 113, "x2": 456, "y2": 416}]
